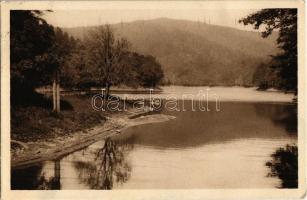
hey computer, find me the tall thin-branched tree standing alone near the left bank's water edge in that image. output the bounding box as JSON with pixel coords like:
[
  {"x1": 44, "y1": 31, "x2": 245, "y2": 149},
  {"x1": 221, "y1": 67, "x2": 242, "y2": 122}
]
[{"x1": 87, "y1": 25, "x2": 129, "y2": 97}]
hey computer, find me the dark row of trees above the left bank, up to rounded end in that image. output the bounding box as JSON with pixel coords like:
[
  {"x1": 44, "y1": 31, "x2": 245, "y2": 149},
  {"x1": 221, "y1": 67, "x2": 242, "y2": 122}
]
[{"x1": 10, "y1": 10, "x2": 163, "y2": 105}]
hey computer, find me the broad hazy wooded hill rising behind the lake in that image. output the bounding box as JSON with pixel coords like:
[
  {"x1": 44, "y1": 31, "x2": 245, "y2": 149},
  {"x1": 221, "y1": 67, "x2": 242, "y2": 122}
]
[{"x1": 63, "y1": 18, "x2": 278, "y2": 86}]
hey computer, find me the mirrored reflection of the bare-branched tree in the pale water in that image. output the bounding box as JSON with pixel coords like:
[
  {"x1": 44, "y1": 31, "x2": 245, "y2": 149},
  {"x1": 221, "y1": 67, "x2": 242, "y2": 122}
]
[{"x1": 74, "y1": 138, "x2": 133, "y2": 190}]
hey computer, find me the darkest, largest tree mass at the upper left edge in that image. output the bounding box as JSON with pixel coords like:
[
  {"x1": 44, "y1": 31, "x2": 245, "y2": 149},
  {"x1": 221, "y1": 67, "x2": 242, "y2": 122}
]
[{"x1": 10, "y1": 10, "x2": 56, "y2": 103}]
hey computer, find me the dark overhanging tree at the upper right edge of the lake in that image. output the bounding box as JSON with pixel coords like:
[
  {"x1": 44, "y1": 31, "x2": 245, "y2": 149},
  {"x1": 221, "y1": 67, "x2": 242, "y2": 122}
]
[{"x1": 239, "y1": 8, "x2": 297, "y2": 94}]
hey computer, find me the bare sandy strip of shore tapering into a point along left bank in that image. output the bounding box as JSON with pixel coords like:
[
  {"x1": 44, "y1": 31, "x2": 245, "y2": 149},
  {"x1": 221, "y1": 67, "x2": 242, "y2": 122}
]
[{"x1": 11, "y1": 111, "x2": 175, "y2": 169}]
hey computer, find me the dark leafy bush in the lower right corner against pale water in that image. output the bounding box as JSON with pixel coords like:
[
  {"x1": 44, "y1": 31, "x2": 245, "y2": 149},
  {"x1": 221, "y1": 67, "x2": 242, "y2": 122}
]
[{"x1": 266, "y1": 145, "x2": 298, "y2": 188}]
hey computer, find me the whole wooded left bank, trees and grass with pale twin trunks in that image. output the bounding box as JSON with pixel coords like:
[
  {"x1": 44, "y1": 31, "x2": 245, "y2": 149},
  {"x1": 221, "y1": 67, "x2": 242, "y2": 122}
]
[{"x1": 10, "y1": 10, "x2": 164, "y2": 141}]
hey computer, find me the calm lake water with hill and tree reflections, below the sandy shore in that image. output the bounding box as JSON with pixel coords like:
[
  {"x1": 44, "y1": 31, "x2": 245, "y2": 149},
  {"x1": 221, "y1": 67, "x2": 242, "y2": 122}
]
[{"x1": 11, "y1": 87, "x2": 297, "y2": 189}]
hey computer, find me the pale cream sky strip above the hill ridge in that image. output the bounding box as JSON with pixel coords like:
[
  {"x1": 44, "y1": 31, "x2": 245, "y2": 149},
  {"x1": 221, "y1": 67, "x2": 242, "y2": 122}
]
[{"x1": 43, "y1": 9, "x2": 257, "y2": 30}]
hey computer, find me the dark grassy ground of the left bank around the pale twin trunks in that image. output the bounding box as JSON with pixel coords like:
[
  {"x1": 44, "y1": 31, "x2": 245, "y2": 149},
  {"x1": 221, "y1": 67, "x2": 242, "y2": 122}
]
[{"x1": 11, "y1": 95, "x2": 127, "y2": 142}]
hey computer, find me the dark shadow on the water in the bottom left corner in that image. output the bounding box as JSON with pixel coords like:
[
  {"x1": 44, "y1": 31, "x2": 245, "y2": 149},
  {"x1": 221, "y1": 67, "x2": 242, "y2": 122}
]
[{"x1": 11, "y1": 160, "x2": 61, "y2": 190}]
